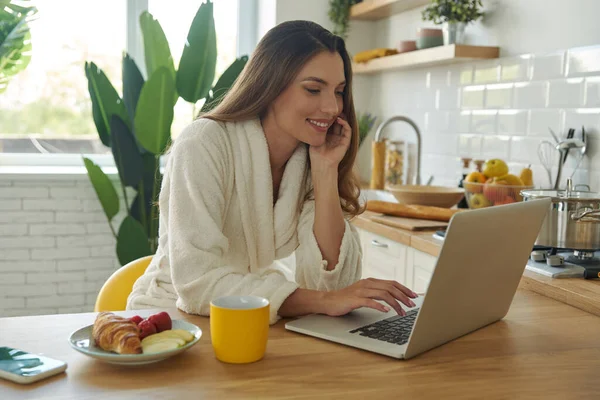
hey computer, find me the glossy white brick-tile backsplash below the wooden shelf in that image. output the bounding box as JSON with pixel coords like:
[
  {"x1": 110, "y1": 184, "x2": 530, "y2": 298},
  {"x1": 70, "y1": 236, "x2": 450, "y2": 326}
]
[{"x1": 358, "y1": 46, "x2": 600, "y2": 190}]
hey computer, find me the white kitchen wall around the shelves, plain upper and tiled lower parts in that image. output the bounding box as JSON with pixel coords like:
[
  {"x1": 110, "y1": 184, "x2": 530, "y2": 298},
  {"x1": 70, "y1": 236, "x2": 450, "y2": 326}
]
[{"x1": 350, "y1": 0, "x2": 600, "y2": 190}]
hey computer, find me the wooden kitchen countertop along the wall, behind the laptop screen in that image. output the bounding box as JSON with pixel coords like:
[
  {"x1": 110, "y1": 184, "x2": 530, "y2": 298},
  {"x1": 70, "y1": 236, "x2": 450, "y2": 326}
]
[{"x1": 352, "y1": 211, "x2": 600, "y2": 316}]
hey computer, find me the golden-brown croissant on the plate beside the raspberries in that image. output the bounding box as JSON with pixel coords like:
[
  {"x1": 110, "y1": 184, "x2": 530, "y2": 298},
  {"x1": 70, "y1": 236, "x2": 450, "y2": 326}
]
[{"x1": 92, "y1": 312, "x2": 142, "y2": 354}]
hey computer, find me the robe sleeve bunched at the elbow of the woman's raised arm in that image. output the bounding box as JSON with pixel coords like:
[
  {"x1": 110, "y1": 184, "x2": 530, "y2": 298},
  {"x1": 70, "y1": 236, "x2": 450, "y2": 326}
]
[{"x1": 295, "y1": 200, "x2": 362, "y2": 291}]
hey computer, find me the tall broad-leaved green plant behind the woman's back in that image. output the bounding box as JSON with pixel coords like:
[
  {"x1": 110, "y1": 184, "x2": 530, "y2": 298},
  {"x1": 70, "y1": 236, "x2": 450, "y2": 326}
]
[{"x1": 82, "y1": 0, "x2": 248, "y2": 265}]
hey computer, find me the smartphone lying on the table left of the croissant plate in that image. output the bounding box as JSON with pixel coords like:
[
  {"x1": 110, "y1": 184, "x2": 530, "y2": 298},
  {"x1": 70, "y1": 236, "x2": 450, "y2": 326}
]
[{"x1": 0, "y1": 347, "x2": 67, "y2": 384}]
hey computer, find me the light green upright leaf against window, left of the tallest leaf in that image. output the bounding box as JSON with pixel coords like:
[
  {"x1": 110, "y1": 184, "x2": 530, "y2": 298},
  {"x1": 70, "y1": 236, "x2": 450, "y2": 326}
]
[{"x1": 140, "y1": 11, "x2": 179, "y2": 104}]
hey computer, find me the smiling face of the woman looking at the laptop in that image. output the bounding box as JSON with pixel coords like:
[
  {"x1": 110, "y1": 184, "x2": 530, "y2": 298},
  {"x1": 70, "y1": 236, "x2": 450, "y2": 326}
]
[{"x1": 265, "y1": 51, "x2": 345, "y2": 146}]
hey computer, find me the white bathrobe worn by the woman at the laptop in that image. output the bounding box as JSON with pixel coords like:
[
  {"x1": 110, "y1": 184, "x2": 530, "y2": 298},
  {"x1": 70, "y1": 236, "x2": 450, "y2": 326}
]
[{"x1": 127, "y1": 119, "x2": 362, "y2": 323}]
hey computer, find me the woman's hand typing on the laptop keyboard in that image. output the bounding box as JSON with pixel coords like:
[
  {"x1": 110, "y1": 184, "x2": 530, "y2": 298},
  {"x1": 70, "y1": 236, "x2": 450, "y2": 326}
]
[{"x1": 322, "y1": 278, "x2": 417, "y2": 316}]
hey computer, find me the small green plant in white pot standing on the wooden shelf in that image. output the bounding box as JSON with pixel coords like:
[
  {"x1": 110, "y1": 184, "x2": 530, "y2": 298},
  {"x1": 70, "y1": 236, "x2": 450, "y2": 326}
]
[{"x1": 422, "y1": 0, "x2": 484, "y2": 45}]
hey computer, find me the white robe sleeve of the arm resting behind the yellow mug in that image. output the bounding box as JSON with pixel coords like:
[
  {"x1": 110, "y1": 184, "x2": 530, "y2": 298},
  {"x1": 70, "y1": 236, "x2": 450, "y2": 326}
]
[{"x1": 165, "y1": 121, "x2": 298, "y2": 323}]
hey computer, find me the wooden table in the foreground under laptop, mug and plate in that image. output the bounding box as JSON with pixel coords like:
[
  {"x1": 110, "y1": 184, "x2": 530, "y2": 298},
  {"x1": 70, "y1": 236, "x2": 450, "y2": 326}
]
[{"x1": 0, "y1": 290, "x2": 600, "y2": 400}]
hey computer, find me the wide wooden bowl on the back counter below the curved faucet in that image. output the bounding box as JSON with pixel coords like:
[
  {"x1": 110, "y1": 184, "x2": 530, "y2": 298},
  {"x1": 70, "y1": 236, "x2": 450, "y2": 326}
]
[{"x1": 385, "y1": 185, "x2": 464, "y2": 208}]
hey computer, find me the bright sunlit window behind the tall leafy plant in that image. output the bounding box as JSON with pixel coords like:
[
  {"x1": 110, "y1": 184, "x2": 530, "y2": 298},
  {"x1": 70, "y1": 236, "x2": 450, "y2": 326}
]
[{"x1": 0, "y1": 0, "x2": 255, "y2": 165}]
